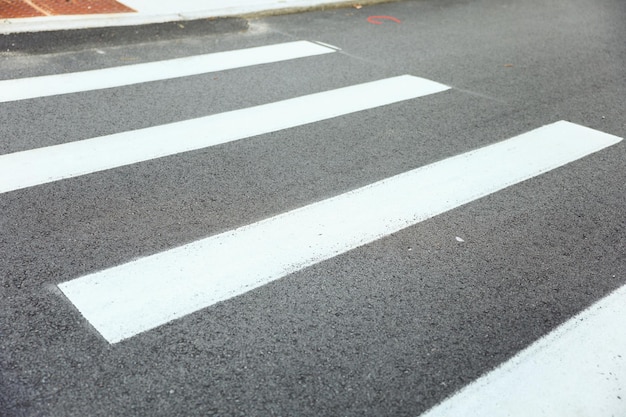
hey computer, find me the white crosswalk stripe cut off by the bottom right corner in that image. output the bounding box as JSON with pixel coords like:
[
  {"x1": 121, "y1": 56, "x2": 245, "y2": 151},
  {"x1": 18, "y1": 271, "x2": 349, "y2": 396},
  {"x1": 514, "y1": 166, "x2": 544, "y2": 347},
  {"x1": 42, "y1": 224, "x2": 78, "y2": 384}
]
[{"x1": 422, "y1": 287, "x2": 626, "y2": 417}]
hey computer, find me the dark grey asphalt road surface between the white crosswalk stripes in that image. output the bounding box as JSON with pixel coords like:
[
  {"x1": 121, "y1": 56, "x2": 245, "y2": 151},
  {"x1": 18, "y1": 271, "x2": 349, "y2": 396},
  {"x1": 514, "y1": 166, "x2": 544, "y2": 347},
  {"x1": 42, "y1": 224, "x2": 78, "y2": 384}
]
[{"x1": 0, "y1": 0, "x2": 626, "y2": 417}]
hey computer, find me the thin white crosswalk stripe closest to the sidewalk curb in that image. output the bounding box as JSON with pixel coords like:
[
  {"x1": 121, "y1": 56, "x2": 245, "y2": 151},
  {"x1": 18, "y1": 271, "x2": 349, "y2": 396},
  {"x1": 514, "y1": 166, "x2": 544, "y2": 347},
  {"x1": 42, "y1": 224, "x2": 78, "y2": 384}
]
[{"x1": 0, "y1": 41, "x2": 335, "y2": 102}]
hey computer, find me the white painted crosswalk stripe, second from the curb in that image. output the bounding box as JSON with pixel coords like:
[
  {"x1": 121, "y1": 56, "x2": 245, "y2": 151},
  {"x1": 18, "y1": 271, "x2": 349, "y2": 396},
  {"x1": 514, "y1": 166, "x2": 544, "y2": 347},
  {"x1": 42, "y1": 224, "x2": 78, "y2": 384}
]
[{"x1": 0, "y1": 75, "x2": 449, "y2": 193}]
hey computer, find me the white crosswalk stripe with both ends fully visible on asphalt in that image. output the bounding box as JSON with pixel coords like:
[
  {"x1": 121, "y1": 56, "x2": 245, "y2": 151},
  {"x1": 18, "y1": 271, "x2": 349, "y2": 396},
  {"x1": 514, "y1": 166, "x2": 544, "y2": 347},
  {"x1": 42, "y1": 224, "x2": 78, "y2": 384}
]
[{"x1": 59, "y1": 121, "x2": 621, "y2": 343}]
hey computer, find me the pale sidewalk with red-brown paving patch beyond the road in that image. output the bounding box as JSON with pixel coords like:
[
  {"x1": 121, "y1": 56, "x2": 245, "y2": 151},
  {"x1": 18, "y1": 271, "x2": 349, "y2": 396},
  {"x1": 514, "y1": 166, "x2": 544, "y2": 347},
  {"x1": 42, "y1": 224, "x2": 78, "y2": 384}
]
[{"x1": 0, "y1": 0, "x2": 382, "y2": 34}]
